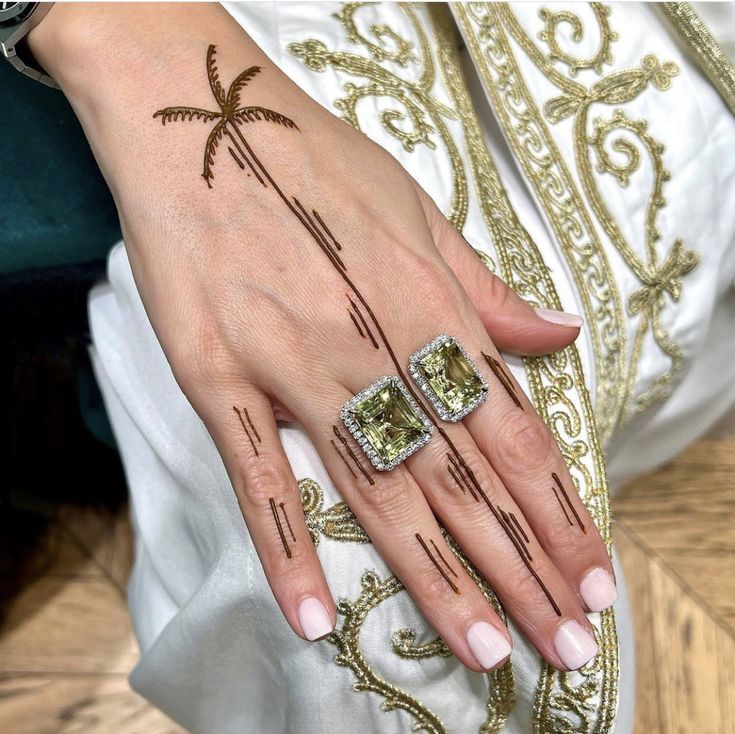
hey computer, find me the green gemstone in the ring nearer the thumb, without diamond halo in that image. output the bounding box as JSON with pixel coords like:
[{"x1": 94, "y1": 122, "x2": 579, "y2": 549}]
[{"x1": 417, "y1": 341, "x2": 484, "y2": 413}]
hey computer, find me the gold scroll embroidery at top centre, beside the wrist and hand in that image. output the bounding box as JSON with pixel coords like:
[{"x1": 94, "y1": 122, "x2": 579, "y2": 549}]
[{"x1": 288, "y1": 3, "x2": 467, "y2": 229}]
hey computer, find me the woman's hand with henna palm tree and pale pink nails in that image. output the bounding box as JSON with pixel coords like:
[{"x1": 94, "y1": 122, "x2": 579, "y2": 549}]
[{"x1": 31, "y1": 4, "x2": 615, "y2": 670}]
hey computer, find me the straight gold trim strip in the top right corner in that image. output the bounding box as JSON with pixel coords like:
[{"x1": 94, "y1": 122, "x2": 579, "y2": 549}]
[{"x1": 659, "y1": 3, "x2": 735, "y2": 115}]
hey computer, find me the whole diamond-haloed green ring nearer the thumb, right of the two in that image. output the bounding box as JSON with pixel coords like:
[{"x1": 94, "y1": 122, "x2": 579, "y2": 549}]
[{"x1": 408, "y1": 334, "x2": 488, "y2": 423}]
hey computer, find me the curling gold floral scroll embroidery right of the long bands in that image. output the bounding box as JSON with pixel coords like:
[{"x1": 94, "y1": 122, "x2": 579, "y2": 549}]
[{"x1": 497, "y1": 3, "x2": 699, "y2": 426}]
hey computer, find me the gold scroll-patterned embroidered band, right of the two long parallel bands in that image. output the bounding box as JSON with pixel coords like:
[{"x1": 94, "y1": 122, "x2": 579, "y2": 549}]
[{"x1": 453, "y1": 3, "x2": 626, "y2": 440}]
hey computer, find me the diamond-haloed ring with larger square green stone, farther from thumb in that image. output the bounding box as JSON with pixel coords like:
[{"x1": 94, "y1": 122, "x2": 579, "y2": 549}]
[{"x1": 339, "y1": 375, "x2": 434, "y2": 471}]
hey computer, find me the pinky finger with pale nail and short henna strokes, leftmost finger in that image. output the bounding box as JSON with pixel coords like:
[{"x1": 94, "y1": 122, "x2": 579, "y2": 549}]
[{"x1": 204, "y1": 385, "x2": 337, "y2": 640}]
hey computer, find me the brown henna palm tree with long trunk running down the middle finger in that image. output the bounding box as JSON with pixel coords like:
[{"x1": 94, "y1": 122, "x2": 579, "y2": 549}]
[{"x1": 153, "y1": 45, "x2": 560, "y2": 614}]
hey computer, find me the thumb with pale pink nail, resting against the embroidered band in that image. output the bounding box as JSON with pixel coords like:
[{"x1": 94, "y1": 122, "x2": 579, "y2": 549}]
[{"x1": 417, "y1": 186, "x2": 584, "y2": 355}]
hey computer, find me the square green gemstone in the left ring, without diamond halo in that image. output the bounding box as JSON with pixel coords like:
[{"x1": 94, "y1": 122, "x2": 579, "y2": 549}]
[{"x1": 352, "y1": 384, "x2": 428, "y2": 464}]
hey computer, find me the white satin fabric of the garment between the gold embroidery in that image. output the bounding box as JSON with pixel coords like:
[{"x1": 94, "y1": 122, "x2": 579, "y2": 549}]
[{"x1": 90, "y1": 3, "x2": 735, "y2": 734}]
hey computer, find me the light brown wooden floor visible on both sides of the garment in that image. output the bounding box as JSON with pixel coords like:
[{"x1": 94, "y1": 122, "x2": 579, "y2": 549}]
[{"x1": 0, "y1": 438, "x2": 735, "y2": 734}]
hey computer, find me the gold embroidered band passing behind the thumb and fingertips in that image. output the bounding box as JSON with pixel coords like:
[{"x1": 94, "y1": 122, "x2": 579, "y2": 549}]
[{"x1": 442, "y1": 4, "x2": 618, "y2": 734}]
